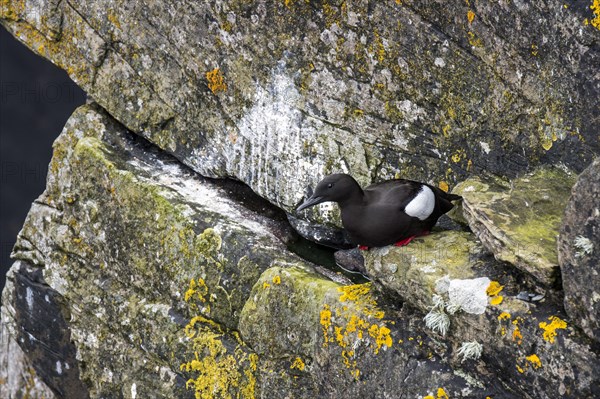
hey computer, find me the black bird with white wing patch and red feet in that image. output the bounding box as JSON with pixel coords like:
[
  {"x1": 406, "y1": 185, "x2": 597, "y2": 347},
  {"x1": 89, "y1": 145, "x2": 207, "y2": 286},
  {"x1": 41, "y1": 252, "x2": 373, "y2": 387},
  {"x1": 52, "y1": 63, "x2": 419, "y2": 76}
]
[{"x1": 297, "y1": 173, "x2": 462, "y2": 250}]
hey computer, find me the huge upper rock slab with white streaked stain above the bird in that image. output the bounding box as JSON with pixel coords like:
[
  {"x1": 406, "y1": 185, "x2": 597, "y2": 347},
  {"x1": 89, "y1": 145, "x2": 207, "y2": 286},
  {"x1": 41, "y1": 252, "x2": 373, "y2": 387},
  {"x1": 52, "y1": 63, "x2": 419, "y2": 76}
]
[{"x1": 0, "y1": 0, "x2": 600, "y2": 242}]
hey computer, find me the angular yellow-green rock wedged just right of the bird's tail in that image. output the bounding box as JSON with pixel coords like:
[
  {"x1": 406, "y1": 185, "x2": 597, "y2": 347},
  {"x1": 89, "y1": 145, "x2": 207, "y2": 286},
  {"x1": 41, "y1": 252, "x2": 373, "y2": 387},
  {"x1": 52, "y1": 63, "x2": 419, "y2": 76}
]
[{"x1": 454, "y1": 167, "x2": 576, "y2": 286}]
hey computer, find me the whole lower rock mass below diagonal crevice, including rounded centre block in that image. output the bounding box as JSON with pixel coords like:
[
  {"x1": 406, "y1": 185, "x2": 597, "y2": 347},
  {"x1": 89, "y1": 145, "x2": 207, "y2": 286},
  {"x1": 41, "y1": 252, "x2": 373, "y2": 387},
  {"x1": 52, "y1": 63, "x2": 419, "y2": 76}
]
[{"x1": 0, "y1": 104, "x2": 519, "y2": 399}]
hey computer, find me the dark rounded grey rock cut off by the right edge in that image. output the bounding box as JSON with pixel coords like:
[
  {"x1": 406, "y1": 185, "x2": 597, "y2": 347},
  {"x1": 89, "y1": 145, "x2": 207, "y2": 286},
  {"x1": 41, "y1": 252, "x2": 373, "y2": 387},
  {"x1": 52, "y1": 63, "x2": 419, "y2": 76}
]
[{"x1": 558, "y1": 159, "x2": 600, "y2": 341}]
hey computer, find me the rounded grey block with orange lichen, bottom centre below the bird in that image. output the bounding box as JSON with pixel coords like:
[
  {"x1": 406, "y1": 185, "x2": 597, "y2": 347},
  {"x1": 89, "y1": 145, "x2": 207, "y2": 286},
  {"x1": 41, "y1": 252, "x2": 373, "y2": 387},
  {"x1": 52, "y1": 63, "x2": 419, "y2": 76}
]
[{"x1": 240, "y1": 267, "x2": 510, "y2": 398}]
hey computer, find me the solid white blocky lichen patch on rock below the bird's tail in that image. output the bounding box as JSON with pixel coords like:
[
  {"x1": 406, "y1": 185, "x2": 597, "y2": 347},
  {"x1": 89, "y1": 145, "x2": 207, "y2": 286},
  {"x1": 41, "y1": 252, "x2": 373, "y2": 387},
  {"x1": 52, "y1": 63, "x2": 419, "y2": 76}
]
[{"x1": 448, "y1": 277, "x2": 490, "y2": 314}]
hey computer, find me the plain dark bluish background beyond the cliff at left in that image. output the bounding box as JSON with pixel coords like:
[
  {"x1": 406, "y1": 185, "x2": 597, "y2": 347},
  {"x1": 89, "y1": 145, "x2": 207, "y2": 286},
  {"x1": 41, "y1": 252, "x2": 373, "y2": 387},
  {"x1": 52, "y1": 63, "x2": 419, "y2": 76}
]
[{"x1": 0, "y1": 26, "x2": 86, "y2": 289}]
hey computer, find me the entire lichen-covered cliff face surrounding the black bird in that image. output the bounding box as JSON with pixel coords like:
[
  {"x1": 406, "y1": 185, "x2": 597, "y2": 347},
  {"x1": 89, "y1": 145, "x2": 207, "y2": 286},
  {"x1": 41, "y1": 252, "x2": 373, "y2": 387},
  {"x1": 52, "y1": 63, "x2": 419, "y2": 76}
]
[{"x1": 0, "y1": 0, "x2": 600, "y2": 398}]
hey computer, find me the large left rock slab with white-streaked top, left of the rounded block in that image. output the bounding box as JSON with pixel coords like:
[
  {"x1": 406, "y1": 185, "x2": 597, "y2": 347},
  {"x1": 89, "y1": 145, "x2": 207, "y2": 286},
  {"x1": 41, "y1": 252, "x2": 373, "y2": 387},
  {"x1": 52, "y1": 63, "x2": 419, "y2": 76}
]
[{"x1": 0, "y1": 105, "x2": 314, "y2": 398}]
